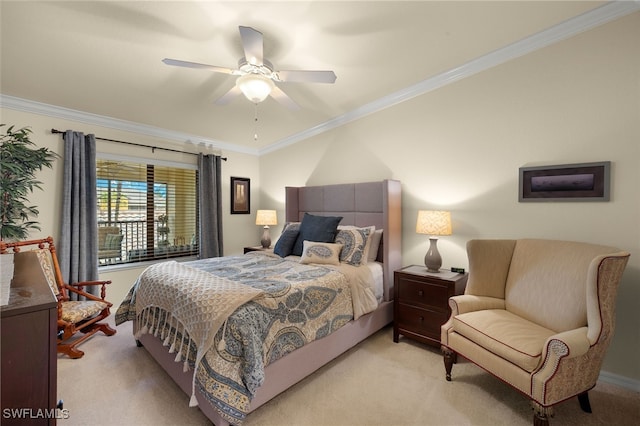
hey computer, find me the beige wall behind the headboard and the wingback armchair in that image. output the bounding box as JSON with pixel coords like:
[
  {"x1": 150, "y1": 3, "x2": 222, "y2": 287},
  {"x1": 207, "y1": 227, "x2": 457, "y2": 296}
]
[{"x1": 260, "y1": 13, "x2": 640, "y2": 381}]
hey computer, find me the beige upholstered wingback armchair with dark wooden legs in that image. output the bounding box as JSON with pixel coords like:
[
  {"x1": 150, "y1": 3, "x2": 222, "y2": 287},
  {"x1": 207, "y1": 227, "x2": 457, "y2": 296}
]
[{"x1": 441, "y1": 239, "x2": 629, "y2": 425}]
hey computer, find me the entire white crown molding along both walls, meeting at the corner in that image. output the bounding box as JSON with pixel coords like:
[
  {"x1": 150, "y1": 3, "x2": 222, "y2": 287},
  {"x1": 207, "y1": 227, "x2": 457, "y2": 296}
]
[{"x1": 0, "y1": 0, "x2": 640, "y2": 156}]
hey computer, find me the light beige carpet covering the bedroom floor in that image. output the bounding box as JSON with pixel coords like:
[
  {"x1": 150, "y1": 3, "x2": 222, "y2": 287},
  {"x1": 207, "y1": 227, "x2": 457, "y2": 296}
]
[{"x1": 58, "y1": 318, "x2": 640, "y2": 426}]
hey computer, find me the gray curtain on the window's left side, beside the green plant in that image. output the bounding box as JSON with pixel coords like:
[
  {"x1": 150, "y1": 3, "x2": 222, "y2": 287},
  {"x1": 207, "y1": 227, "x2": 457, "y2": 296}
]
[{"x1": 58, "y1": 130, "x2": 98, "y2": 291}]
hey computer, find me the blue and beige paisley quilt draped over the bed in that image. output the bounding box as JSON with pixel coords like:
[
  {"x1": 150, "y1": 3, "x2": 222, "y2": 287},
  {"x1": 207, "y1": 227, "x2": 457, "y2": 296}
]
[{"x1": 116, "y1": 252, "x2": 375, "y2": 424}]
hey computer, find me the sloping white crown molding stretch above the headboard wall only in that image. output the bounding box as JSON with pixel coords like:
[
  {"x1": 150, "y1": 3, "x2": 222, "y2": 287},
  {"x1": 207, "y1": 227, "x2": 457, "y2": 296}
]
[{"x1": 259, "y1": 0, "x2": 640, "y2": 155}]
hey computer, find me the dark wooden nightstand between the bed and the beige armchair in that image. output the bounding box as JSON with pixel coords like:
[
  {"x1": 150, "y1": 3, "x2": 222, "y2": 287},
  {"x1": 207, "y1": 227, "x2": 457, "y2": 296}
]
[{"x1": 393, "y1": 265, "x2": 468, "y2": 347}]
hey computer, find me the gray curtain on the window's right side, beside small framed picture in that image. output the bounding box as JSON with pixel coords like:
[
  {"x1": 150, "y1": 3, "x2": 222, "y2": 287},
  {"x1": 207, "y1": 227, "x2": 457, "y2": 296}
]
[{"x1": 198, "y1": 154, "x2": 223, "y2": 259}]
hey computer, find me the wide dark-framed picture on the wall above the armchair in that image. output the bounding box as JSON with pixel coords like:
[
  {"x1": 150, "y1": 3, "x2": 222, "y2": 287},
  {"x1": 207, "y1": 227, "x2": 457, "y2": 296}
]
[{"x1": 519, "y1": 161, "x2": 611, "y2": 202}]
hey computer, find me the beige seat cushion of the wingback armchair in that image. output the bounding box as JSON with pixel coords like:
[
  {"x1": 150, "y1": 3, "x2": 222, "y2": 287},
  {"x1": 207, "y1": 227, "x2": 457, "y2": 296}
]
[{"x1": 453, "y1": 309, "x2": 555, "y2": 372}]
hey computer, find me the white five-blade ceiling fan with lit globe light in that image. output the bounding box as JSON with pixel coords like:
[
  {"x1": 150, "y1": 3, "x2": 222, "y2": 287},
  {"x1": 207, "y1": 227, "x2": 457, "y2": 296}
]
[{"x1": 162, "y1": 26, "x2": 336, "y2": 109}]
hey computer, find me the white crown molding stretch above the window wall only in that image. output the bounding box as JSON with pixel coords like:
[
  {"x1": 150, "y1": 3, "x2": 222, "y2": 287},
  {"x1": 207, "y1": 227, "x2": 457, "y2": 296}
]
[{"x1": 0, "y1": 94, "x2": 258, "y2": 155}]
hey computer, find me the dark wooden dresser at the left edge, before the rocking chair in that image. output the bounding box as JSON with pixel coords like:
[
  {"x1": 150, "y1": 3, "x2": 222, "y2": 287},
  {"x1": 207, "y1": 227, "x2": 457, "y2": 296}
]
[{"x1": 0, "y1": 276, "x2": 58, "y2": 425}]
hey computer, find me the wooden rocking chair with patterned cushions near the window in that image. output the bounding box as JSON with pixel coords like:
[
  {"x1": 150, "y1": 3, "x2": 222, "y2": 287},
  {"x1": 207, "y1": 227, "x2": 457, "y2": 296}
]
[{"x1": 0, "y1": 237, "x2": 116, "y2": 358}]
